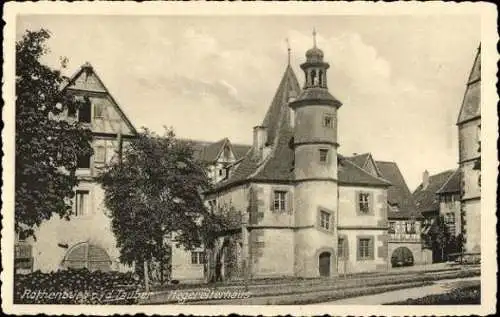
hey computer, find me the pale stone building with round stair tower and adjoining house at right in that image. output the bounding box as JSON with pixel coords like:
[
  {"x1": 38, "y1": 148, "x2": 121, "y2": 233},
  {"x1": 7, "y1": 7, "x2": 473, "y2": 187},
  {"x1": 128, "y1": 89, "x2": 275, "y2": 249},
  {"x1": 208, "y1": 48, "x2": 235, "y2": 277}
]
[{"x1": 203, "y1": 35, "x2": 427, "y2": 278}]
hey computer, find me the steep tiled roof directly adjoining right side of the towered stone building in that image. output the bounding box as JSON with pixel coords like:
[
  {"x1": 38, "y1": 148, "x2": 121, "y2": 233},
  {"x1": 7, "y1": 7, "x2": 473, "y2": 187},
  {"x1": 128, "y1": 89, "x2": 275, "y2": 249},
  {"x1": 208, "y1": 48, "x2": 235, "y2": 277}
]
[{"x1": 376, "y1": 161, "x2": 422, "y2": 219}]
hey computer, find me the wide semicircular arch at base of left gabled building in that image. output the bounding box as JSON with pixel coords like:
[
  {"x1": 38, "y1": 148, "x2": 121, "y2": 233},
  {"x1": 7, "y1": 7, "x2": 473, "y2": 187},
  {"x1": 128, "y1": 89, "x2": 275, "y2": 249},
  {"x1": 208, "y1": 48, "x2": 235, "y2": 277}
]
[{"x1": 62, "y1": 242, "x2": 111, "y2": 272}]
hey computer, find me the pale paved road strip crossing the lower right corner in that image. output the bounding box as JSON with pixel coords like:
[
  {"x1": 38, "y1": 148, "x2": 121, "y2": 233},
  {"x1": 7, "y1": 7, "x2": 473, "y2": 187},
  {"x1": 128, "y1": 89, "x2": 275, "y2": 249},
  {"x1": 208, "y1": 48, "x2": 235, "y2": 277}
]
[{"x1": 314, "y1": 277, "x2": 481, "y2": 305}]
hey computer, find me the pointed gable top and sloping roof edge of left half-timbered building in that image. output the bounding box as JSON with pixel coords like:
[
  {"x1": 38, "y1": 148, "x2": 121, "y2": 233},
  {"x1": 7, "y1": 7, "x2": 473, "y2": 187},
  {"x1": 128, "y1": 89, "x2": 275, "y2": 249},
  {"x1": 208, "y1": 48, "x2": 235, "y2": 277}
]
[{"x1": 60, "y1": 62, "x2": 137, "y2": 134}]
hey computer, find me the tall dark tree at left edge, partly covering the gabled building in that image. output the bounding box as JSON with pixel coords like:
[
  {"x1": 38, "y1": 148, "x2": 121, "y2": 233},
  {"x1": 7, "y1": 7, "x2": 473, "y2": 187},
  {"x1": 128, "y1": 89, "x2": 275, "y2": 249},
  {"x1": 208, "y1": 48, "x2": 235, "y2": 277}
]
[{"x1": 15, "y1": 29, "x2": 92, "y2": 236}]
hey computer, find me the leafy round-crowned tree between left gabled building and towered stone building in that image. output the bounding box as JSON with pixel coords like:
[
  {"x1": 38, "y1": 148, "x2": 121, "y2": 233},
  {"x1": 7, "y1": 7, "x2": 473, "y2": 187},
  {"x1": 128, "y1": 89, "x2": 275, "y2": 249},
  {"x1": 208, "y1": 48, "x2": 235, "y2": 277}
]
[{"x1": 97, "y1": 129, "x2": 210, "y2": 286}]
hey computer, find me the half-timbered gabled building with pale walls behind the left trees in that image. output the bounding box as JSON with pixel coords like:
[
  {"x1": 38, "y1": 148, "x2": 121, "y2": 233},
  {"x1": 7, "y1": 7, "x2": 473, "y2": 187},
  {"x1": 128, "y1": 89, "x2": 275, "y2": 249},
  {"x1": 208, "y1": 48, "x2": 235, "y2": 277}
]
[{"x1": 16, "y1": 63, "x2": 136, "y2": 272}]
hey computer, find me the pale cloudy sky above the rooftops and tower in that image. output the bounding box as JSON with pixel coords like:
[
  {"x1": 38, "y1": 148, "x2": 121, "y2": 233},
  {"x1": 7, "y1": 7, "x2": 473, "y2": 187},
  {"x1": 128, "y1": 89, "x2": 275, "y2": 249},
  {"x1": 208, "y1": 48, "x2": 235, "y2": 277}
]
[{"x1": 16, "y1": 15, "x2": 481, "y2": 191}]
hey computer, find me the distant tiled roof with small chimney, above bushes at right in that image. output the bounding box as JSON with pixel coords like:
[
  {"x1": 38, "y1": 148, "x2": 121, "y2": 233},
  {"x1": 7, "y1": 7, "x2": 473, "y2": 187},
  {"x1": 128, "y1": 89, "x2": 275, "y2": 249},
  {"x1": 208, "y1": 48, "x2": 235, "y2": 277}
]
[{"x1": 413, "y1": 170, "x2": 455, "y2": 213}]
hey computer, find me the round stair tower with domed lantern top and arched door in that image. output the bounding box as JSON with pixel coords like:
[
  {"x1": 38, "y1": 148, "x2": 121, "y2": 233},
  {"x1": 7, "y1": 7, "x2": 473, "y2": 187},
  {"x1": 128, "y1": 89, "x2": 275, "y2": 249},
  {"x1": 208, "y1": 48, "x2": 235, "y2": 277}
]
[{"x1": 289, "y1": 31, "x2": 342, "y2": 277}]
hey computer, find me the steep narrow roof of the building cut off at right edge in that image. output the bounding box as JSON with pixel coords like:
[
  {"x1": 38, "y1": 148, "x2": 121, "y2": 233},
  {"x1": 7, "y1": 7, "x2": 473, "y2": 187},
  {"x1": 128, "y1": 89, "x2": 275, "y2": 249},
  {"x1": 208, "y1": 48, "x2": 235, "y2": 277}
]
[{"x1": 457, "y1": 45, "x2": 481, "y2": 124}]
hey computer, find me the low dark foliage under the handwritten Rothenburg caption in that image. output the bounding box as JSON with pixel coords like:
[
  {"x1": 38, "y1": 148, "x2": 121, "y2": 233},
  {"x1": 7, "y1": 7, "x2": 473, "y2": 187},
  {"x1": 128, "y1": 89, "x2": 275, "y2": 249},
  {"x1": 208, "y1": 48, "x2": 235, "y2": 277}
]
[{"x1": 14, "y1": 269, "x2": 143, "y2": 305}]
